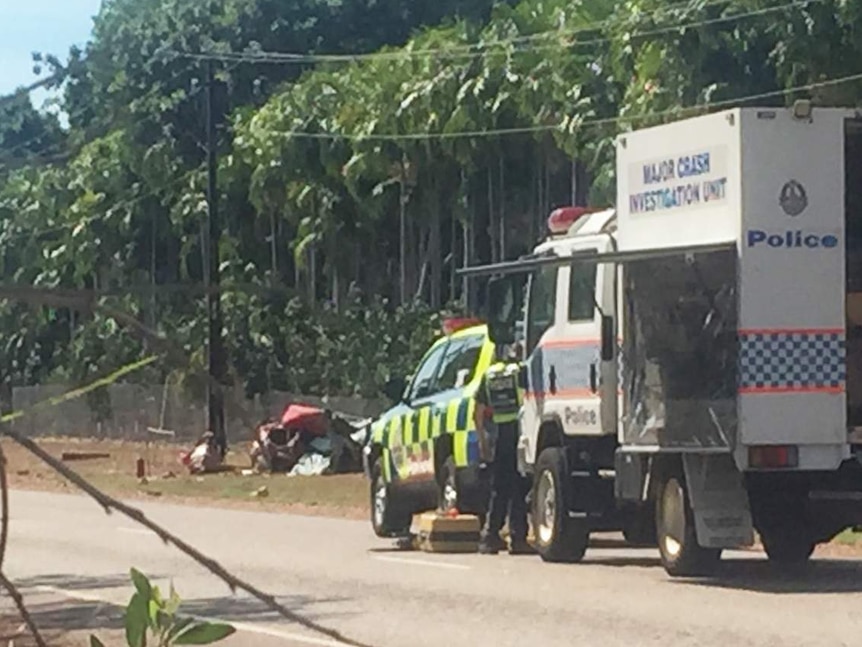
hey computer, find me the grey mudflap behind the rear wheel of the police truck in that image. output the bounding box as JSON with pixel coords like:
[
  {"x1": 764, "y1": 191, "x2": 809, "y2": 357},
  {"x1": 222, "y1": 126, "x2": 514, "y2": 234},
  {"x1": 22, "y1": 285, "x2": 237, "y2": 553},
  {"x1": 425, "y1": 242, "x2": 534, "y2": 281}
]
[{"x1": 682, "y1": 453, "x2": 754, "y2": 548}]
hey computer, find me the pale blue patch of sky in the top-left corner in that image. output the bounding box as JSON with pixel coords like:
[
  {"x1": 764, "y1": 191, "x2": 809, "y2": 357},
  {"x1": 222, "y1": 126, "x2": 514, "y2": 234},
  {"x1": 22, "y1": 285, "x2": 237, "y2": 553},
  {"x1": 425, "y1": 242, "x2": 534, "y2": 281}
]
[{"x1": 0, "y1": 0, "x2": 102, "y2": 106}]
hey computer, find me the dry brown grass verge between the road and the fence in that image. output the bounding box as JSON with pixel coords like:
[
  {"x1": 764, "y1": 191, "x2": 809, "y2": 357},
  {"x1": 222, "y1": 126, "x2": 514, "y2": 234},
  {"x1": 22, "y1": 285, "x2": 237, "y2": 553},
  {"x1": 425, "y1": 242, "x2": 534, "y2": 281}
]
[{"x1": 2, "y1": 438, "x2": 368, "y2": 518}]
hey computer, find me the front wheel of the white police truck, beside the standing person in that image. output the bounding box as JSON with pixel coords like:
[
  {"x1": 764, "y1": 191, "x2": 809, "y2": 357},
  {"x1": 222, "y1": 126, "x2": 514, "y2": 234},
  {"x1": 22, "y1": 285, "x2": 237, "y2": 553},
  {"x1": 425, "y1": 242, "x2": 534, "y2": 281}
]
[{"x1": 531, "y1": 447, "x2": 590, "y2": 563}]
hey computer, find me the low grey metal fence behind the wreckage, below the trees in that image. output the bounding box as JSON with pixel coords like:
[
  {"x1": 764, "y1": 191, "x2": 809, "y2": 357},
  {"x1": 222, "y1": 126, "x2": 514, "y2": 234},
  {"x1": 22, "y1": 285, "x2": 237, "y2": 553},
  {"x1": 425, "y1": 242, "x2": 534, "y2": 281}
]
[{"x1": 12, "y1": 384, "x2": 387, "y2": 440}]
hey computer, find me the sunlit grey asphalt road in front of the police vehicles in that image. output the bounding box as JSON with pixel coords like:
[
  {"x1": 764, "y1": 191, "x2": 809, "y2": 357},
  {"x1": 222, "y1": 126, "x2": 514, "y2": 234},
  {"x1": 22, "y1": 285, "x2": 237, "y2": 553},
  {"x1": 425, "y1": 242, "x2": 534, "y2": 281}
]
[{"x1": 6, "y1": 492, "x2": 862, "y2": 647}]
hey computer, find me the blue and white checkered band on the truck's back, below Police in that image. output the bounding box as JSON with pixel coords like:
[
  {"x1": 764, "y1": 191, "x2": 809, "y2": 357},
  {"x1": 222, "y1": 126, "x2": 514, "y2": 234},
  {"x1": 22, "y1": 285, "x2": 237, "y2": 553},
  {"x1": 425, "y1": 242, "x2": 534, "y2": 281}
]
[{"x1": 739, "y1": 330, "x2": 847, "y2": 393}]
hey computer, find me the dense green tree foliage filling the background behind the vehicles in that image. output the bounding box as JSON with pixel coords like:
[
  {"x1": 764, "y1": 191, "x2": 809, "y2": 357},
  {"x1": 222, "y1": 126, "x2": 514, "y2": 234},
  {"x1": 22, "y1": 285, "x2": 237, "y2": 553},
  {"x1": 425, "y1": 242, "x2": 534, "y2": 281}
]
[{"x1": 0, "y1": 0, "x2": 862, "y2": 395}]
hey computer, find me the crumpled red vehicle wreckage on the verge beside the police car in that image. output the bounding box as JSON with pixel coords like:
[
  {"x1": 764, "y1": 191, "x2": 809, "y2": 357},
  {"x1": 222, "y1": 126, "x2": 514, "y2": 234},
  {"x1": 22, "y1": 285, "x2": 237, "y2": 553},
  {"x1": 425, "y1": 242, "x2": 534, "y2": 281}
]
[{"x1": 250, "y1": 404, "x2": 368, "y2": 476}]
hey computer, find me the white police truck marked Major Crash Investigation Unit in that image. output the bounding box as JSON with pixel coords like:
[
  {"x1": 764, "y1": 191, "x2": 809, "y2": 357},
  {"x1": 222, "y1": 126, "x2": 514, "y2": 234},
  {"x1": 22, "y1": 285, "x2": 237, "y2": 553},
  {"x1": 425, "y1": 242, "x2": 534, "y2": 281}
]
[{"x1": 462, "y1": 102, "x2": 862, "y2": 576}]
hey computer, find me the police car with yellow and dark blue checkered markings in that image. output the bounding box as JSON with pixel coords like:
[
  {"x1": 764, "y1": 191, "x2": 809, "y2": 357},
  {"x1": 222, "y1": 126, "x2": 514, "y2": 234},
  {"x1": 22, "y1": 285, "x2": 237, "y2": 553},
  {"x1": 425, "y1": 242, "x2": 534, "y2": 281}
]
[{"x1": 363, "y1": 319, "x2": 494, "y2": 537}]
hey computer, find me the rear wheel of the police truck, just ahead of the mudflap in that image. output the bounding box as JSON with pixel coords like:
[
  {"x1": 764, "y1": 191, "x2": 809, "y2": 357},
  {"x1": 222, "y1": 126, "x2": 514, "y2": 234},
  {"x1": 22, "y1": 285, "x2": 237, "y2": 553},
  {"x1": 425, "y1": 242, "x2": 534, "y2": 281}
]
[{"x1": 656, "y1": 475, "x2": 721, "y2": 577}]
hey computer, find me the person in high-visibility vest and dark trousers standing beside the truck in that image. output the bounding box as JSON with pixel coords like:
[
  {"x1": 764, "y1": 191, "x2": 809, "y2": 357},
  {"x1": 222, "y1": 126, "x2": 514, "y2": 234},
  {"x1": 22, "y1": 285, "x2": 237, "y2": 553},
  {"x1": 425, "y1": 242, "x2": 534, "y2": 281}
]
[{"x1": 474, "y1": 344, "x2": 533, "y2": 555}]
